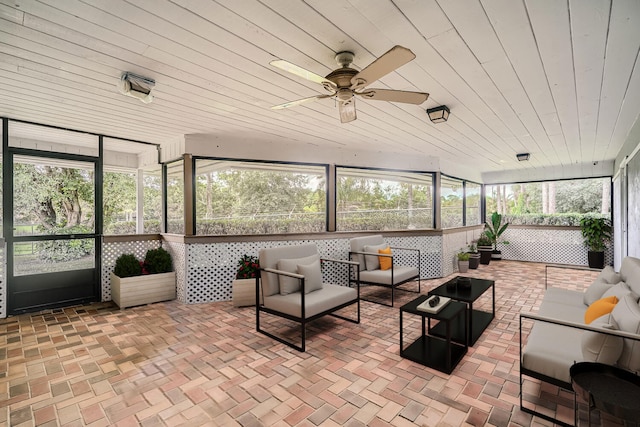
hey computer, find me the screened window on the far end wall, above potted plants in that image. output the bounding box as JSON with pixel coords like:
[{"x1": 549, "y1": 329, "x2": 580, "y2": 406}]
[{"x1": 486, "y1": 178, "x2": 611, "y2": 226}]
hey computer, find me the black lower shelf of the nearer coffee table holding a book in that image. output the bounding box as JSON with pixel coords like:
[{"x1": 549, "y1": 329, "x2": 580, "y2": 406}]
[{"x1": 400, "y1": 335, "x2": 467, "y2": 374}]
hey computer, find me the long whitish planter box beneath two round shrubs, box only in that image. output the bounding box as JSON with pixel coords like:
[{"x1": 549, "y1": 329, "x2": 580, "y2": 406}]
[{"x1": 111, "y1": 271, "x2": 176, "y2": 308}]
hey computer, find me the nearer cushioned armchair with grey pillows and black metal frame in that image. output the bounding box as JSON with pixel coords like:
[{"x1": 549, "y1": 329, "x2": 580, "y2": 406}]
[{"x1": 256, "y1": 244, "x2": 360, "y2": 351}]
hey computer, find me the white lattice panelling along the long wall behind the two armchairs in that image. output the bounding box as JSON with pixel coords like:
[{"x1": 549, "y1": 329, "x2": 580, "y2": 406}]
[{"x1": 185, "y1": 236, "x2": 441, "y2": 304}]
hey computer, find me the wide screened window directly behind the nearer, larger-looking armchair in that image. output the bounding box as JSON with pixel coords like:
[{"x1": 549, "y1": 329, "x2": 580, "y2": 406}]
[{"x1": 195, "y1": 159, "x2": 327, "y2": 235}]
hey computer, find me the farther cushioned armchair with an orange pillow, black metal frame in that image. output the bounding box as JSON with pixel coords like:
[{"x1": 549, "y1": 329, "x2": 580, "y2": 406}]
[{"x1": 349, "y1": 234, "x2": 421, "y2": 307}]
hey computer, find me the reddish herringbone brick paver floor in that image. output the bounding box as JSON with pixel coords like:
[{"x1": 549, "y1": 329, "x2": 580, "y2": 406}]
[{"x1": 0, "y1": 261, "x2": 621, "y2": 426}]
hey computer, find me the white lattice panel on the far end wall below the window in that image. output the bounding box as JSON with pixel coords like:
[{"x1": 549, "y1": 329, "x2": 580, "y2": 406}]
[{"x1": 498, "y1": 228, "x2": 613, "y2": 265}]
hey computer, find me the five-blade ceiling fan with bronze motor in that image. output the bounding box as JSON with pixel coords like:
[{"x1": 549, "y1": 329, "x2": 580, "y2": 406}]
[{"x1": 270, "y1": 46, "x2": 429, "y2": 123}]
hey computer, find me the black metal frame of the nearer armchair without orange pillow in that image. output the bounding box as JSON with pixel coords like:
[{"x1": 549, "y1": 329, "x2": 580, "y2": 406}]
[{"x1": 256, "y1": 258, "x2": 360, "y2": 352}]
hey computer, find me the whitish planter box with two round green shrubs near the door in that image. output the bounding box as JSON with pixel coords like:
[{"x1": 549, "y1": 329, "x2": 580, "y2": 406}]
[{"x1": 111, "y1": 248, "x2": 176, "y2": 308}]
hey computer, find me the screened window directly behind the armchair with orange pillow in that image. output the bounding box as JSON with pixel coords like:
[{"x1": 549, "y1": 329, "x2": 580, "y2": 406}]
[{"x1": 336, "y1": 167, "x2": 433, "y2": 231}]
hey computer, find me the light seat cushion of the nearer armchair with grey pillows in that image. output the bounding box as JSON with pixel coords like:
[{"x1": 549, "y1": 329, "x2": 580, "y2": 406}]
[{"x1": 264, "y1": 283, "x2": 358, "y2": 319}]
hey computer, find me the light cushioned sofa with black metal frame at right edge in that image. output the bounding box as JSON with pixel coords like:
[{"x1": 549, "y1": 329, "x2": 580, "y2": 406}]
[{"x1": 520, "y1": 257, "x2": 640, "y2": 421}]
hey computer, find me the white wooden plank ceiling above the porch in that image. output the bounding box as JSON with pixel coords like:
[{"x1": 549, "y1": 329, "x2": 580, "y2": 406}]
[{"x1": 0, "y1": 0, "x2": 640, "y2": 179}]
